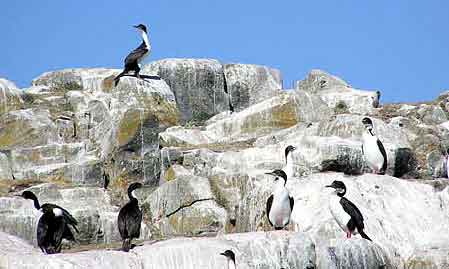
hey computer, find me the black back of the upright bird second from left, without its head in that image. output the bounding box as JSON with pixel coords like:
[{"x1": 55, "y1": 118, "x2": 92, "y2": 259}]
[{"x1": 118, "y1": 199, "x2": 142, "y2": 239}]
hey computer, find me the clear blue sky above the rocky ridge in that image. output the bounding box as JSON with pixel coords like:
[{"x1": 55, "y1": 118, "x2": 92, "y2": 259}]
[{"x1": 0, "y1": 0, "x2": 449, "y2": 102}]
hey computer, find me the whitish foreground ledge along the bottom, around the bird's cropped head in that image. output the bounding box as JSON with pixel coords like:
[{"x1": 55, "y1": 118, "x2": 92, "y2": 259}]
[{"x1": 0, "y1": 232, "x2": 315, "y2": 269}]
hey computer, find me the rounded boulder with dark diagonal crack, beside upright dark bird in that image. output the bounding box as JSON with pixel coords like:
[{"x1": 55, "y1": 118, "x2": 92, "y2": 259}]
[{"x1": 142, "y1": 176, "x2": 226, "y2": 236}]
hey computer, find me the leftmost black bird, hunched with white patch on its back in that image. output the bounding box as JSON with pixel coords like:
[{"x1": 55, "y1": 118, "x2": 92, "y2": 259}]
[{"x1": 19, "y1": 191, "x2": 79, "y2": 254}]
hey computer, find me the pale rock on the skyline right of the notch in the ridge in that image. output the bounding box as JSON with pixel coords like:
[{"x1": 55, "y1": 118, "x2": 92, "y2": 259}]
[{"x1": 297, "y1": 70, "x2": 379, "y2": 114}]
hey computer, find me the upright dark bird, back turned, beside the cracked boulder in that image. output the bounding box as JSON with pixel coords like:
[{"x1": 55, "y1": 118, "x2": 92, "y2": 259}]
[{"x1": 118, "y1": 182, "x2": 142, "y2": 252}]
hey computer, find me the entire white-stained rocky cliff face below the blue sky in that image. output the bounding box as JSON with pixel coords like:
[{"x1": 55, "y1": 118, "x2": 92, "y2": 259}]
[{"x1": 0, "y1": 59, "x2": 449, "y2": 268}]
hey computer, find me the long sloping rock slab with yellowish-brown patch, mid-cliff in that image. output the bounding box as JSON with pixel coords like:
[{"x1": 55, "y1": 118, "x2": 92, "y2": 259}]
[{"x1": 160, "y1": 93, "x2": 329, "y2": 146}]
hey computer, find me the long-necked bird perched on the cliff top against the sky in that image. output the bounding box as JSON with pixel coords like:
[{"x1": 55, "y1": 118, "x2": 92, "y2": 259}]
[{"x1": 114, "y1": 24, "x2": 151, "y2": 86}]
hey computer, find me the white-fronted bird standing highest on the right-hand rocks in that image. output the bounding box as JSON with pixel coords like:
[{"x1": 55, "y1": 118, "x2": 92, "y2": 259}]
[{"x1": 362, "y1": 118, "x2": 387, "y2": 175}]
